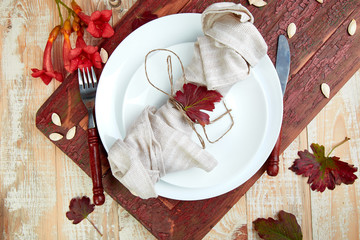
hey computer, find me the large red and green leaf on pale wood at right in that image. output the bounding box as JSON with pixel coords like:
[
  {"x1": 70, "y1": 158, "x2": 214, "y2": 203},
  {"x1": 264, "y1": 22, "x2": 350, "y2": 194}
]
[{"x1": 289, "y1": 142, "x2": 357, "y2": 192}]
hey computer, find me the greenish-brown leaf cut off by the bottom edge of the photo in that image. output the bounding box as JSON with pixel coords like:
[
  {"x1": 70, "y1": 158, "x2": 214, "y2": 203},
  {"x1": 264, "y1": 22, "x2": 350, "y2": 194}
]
[{"x1": 253, "y1": 210, "x2": 303, "y2": 240}]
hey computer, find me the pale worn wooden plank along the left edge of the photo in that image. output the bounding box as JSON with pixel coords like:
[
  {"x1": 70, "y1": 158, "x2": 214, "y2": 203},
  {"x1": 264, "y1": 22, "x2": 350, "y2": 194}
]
[{"x1": 0, "y1": 1, "x2": 57, "y2": 239}]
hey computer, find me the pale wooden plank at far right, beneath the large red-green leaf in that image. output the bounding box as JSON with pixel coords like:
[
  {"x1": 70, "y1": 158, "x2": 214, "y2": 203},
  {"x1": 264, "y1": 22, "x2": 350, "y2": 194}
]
[{"x1": 308, "y1": 72, "x2": 360, "y2": 239}]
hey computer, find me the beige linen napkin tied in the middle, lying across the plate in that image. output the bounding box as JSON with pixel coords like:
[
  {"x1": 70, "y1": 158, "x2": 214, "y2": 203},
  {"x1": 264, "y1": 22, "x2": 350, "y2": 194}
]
[{"x1": 108, "y1": 3, "x2": 267, "y2": 199}]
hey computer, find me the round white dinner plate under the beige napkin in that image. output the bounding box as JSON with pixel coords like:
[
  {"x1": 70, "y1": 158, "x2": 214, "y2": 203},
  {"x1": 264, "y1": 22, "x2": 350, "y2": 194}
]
[{"x1": 95, "y1": 13, "x2": 283, "y2": 200}]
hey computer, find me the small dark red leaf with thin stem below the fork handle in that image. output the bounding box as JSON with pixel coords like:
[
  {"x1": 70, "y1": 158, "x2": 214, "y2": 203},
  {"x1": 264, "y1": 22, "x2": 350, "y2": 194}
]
[{"x1": 66, "y1": 196, "x2": 95, "y2": 224}]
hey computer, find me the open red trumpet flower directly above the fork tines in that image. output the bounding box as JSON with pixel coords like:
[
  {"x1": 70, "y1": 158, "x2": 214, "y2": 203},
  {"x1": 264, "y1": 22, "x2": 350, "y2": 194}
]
[{"x1": 69, "y1": 32, "x2": 102, "y2": 72}]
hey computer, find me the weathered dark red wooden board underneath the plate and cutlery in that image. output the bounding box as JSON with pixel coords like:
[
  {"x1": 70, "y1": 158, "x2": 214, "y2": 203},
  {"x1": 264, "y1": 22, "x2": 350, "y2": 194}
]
[{"x1": 36, "y1": 0, "x2": 360, "y2": 239}]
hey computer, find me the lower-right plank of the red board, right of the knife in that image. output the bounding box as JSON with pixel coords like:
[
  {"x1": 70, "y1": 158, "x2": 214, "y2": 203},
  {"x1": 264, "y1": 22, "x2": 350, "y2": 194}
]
[{"x1": 281, "y1": 3, "x2": 360, "y2": 154}]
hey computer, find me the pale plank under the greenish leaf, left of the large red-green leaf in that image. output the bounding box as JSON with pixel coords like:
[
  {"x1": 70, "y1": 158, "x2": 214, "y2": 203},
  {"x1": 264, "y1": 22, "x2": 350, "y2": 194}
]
[{"x1": 246, "y1": 130, "x2": 312, "y2": 239}]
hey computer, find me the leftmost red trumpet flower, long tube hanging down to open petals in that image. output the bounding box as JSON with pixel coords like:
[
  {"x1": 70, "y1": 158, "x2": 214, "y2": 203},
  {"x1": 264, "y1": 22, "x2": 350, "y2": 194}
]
[{"x1": 31, "y1": 26, "x2": 63, "y2": 85}]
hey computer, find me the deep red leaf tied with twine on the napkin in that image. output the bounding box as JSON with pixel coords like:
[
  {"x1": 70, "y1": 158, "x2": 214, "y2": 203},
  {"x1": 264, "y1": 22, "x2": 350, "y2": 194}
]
[{"x1": 174, "y1": 83, "x2": 222, "y2": 126}]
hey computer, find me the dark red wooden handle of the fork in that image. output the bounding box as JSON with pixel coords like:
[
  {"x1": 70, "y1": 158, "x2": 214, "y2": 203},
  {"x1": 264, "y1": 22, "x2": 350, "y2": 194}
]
[{"x1": 87, "y1": 128, "x2": 105, "y2": 205}]
